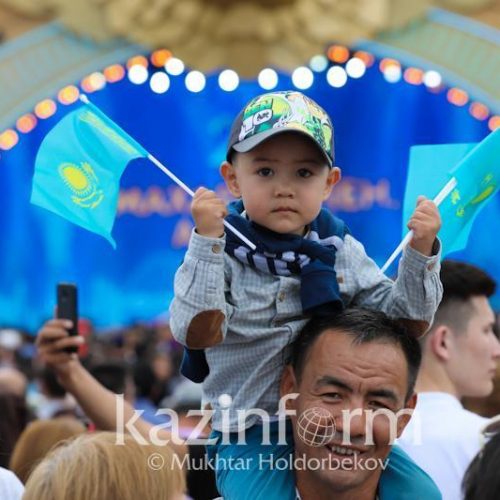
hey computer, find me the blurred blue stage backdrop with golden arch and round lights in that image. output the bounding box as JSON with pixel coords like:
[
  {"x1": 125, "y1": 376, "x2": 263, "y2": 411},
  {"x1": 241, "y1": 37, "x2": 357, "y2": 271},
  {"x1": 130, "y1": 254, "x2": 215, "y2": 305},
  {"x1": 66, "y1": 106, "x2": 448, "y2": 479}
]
[{"x1": 0, "y1": 0, "x2": 500, "y2": 352}]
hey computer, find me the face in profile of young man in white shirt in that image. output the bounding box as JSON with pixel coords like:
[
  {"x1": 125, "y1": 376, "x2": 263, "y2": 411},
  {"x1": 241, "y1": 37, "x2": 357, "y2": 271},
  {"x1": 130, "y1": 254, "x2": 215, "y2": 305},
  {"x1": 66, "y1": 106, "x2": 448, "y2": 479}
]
[{"x1": 449, "y1": 296, "x2": 500, "y2": 397}]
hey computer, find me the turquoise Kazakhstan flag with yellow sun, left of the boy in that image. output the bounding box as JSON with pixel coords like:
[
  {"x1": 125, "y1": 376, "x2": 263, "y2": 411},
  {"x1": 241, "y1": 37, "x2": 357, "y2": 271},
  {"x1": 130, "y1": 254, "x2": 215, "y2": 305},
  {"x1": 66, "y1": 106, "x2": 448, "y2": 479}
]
[{"x1": 31, "y1": 103, "x2": 148, "y2": 248}]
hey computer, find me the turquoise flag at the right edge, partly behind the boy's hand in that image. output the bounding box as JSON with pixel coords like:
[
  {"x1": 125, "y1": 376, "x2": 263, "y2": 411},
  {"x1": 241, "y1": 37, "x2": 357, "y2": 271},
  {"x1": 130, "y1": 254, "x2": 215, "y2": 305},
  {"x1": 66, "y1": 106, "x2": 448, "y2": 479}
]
[{"x1": 403, "y1": 129, "x2": 500, "y2": 256}]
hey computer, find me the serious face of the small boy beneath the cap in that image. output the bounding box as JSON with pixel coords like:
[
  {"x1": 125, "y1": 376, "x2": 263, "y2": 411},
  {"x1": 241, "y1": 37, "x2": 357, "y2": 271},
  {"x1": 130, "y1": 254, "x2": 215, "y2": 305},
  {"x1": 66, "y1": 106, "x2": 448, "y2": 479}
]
[{"x1": 221, "y1": 132, "x2": 340, "y2": 235}]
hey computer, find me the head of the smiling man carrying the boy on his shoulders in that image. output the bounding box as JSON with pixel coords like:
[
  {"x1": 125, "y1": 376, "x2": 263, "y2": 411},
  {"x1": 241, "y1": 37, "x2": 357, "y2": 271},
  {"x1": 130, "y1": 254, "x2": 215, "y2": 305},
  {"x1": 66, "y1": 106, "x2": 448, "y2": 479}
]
[{"x1": 281, "y1": 309, "x2": 421, "y2": 492}]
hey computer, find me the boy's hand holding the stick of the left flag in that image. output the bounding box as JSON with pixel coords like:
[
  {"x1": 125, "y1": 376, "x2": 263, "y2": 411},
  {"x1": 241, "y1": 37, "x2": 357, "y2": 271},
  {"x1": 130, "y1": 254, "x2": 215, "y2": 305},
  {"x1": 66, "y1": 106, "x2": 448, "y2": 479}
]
[{"x1": 191, "y1": 188, "x2": 227, "y2": 238}]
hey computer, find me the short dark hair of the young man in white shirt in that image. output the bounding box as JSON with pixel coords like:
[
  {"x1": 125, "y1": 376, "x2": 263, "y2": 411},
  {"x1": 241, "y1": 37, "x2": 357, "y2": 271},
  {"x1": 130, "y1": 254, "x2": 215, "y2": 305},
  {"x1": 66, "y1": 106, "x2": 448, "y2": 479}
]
[{"x1": 434, "y1": 260, "x2": 496, "y2": 332}]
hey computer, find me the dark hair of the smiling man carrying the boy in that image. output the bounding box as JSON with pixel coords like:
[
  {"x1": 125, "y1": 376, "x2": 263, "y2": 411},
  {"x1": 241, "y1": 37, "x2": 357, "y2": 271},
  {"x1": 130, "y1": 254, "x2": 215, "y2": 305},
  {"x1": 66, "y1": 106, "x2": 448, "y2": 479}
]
[{"x1": 290, "y1": 309, "x2": 422, "y2": 400}]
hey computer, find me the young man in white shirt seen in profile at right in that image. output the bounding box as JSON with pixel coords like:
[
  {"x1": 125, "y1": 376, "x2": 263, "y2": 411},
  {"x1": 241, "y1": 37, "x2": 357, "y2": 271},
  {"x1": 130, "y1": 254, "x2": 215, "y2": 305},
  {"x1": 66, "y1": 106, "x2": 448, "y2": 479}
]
[{"x1": 400, "y1": 260, "x2": 500, "y2": 500}]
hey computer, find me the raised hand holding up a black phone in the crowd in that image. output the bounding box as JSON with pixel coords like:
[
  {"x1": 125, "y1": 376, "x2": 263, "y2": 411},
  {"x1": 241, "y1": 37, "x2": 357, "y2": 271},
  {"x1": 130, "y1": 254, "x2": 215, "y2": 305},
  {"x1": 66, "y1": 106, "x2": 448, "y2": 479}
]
[{"x1": 36, "y1": 319, "x2": 85, "y2": 386}]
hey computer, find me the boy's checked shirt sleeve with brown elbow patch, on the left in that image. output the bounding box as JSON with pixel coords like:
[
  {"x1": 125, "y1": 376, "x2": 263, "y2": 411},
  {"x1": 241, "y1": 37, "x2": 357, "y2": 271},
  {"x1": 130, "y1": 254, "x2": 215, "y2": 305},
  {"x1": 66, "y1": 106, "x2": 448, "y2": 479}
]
[{"x1": 170, "y1": 231, "x2": 230, "y2": 349}]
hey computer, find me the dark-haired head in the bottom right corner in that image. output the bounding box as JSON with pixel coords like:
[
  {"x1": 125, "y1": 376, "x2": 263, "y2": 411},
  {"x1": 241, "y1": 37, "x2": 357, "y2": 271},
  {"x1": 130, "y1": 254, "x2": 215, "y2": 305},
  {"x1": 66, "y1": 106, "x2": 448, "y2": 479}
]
[{"x1": 462, "y1": 415, "x2": 500, "y2": 500}]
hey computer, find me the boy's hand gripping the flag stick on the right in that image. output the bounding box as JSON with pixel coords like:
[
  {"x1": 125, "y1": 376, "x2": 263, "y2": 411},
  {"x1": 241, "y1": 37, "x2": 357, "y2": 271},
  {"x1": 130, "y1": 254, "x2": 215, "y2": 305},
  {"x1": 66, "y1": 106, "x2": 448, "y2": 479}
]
[{"x1": 408, "y1": 196, "x2": 441, "y2": 256}]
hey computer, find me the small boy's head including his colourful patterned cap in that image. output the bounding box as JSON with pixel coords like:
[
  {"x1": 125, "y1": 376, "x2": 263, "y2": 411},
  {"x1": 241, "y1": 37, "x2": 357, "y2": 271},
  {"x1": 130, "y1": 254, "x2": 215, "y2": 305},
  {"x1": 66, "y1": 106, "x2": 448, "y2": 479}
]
[{"x1": 221, "y1": 91, "x2": 340, "y2": 234}]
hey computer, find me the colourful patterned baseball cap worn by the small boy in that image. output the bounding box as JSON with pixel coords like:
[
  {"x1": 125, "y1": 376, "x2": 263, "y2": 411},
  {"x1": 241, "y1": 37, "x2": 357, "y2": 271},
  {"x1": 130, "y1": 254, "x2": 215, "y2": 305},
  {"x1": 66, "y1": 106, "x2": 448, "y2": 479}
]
[{"x1": 226, "y1": 90, "x2": 334, "y2": 167}]
